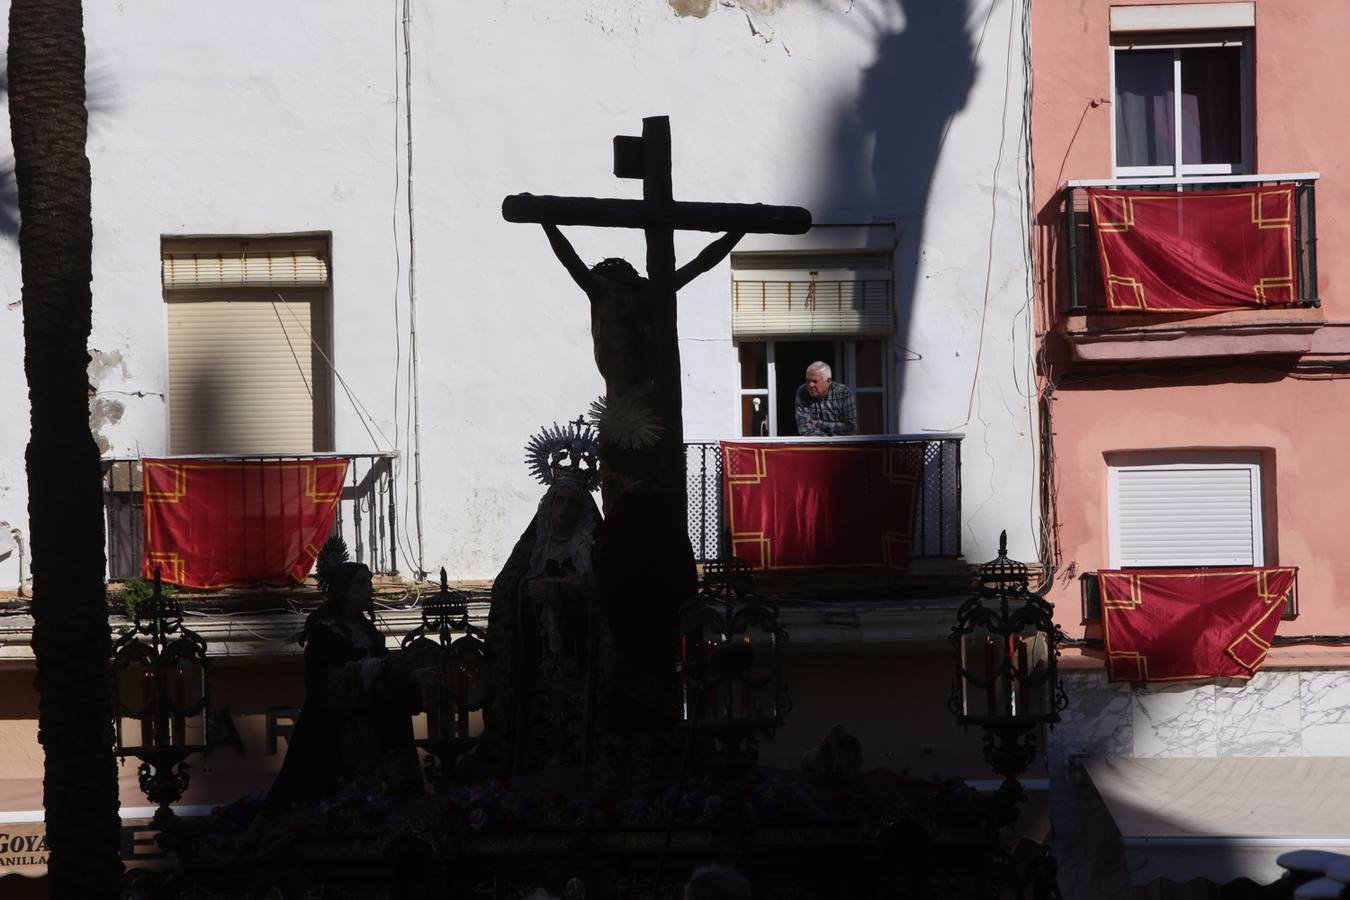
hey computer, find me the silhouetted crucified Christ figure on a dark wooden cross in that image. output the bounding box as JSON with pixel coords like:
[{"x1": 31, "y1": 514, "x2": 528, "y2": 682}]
[{"x1": 502, "y1": 116, "x2": 811, "y2": 783}]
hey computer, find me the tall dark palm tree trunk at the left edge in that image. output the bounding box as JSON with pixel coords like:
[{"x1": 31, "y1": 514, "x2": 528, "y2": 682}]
[{"x1": 9, "y1": 0, "x2": 122, "y2": 899}]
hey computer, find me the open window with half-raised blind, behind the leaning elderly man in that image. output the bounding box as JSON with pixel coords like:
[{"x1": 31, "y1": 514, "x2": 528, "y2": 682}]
[{"x1": 732, "y1": 250, "x2": 895, "y2": 437}]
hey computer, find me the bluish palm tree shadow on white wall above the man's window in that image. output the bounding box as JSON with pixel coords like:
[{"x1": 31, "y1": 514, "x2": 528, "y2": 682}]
[{"x1": 813, "y1": 0, "x2": 982, "y2": 407}]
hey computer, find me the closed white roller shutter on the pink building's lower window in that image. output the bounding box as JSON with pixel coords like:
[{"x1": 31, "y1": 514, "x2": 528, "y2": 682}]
[{"x1": 1114, "y1": 464, "x2": 1264, "y2": 568}]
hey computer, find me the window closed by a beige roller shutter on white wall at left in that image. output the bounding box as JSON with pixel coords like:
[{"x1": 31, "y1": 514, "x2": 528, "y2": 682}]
[{"x1": 161, "y1": 236, "x2": 332, "y2": 455}]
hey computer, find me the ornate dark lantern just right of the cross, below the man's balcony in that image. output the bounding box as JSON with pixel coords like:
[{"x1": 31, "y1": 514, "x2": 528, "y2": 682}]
[{"x1": 679, "y1": 557, "x2": 791, "y2": 770}]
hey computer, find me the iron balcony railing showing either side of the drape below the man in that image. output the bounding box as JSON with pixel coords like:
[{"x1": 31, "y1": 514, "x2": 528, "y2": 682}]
[{"x1": 684, "y1": 434, "x2": 961, "y2": 563}]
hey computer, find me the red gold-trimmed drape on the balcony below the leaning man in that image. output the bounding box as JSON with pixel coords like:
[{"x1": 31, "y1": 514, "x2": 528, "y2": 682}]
[{"x1": 721, "y1": 441, "x2": 925, "y2": 571}]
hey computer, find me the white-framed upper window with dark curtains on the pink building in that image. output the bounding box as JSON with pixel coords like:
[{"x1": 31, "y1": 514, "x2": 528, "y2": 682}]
[{"x1": 1111, "y1": 31, "x2": 1253, "y2": 178}]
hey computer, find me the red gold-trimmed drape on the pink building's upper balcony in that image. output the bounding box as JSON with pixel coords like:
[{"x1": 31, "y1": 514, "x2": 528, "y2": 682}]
[{"x1": 1088, "y1": 185, "x2": 1297, "y2": 313}]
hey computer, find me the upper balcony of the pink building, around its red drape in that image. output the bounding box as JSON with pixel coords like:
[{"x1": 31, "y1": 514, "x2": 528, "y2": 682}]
[{"x1": 1052, "y1": 173, "x2": 1331, "y2": 362}]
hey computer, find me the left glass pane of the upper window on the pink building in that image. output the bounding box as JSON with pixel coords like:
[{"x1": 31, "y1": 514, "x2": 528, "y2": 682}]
[{"x1": 1115, "y1": 50, "x2": 1176, "y2": 166}]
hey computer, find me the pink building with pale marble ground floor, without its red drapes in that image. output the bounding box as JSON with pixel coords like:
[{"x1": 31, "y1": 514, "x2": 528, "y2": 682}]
[{"x1": 1031, "y1": 0, "x2": 1350, "y2": 897}]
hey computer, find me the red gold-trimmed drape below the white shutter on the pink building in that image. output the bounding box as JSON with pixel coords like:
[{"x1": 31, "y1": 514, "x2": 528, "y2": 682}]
[{"x1": 1098, "y1": 567, "x2": 1299, "y2": 681}]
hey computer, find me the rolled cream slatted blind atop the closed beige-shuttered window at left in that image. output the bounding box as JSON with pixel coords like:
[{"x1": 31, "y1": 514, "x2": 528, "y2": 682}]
[{"x1": 163, "y1": 239, "x2": 328, "y2": 290}]
